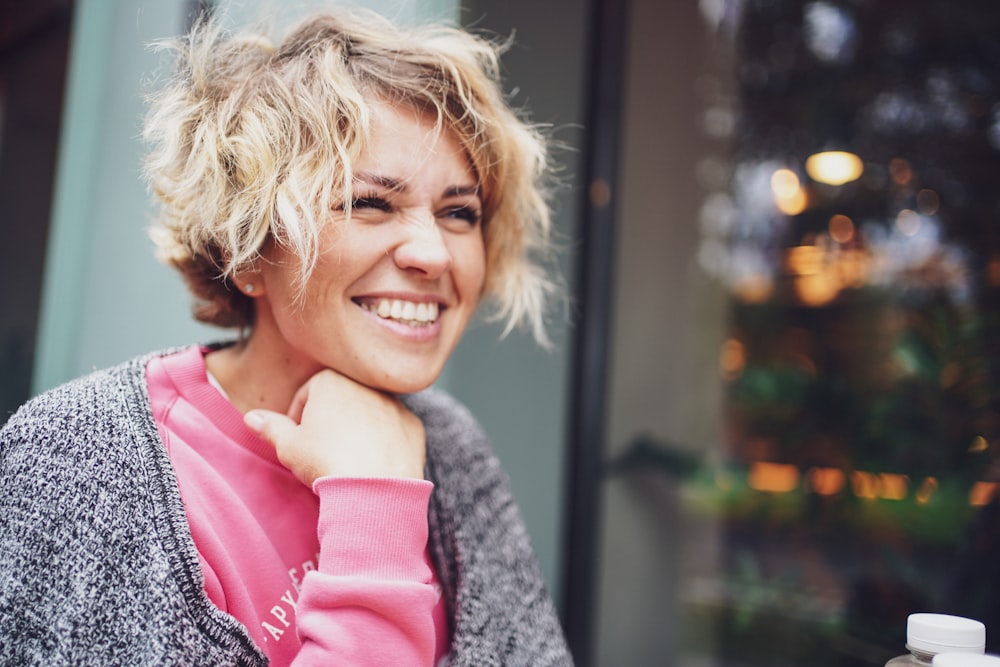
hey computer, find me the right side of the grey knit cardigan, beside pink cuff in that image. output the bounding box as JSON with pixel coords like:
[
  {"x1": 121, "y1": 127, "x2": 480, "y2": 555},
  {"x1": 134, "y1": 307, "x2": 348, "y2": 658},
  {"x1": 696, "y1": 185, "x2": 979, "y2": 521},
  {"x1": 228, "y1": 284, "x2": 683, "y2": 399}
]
[{"x1": 406, "y1": 390, "x2": 572, "y2": 667}]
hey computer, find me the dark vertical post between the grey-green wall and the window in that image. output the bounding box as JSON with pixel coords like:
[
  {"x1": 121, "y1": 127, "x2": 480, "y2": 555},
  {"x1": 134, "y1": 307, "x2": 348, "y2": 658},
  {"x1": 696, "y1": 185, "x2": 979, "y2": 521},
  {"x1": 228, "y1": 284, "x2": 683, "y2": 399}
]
[{"x1": 562, "y1": 0, "x2": 628, "y2": 667}]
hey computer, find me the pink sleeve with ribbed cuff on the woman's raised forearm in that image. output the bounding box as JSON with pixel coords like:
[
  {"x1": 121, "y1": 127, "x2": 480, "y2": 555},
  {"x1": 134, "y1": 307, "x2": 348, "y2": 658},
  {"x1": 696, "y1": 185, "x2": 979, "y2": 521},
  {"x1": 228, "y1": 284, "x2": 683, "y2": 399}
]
[{"x1": 294, "y1": 477, "x2": 436, "y2": 667}]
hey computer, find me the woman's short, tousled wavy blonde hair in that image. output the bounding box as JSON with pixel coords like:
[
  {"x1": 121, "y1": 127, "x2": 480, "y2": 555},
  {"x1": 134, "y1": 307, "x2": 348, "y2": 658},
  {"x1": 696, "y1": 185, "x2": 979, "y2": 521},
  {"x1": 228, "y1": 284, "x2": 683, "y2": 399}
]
[{"x1": 144, "y1": 11, "x2": 553, "y2": 344}]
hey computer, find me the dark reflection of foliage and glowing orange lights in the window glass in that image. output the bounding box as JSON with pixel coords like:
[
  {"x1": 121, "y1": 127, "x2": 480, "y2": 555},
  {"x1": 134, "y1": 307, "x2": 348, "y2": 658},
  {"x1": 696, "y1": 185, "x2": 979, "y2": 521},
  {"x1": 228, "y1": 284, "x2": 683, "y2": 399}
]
[{"x1": 685, "y1": 0, "x2": 1000, "y2": 665}]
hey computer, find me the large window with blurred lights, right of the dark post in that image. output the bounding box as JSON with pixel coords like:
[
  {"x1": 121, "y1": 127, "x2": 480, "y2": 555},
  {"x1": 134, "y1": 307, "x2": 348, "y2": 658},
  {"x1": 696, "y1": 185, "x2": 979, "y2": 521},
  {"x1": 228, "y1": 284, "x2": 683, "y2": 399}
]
[{"x1": 597, "y1": 0, "x2": 1000, "y2": 667}]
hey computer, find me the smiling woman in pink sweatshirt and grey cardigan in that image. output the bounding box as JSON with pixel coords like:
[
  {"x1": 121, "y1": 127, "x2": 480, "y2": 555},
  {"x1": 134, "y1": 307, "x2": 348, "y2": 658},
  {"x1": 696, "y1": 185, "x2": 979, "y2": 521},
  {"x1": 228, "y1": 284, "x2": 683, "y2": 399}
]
[{"x1": 0, "y1": 9, "x2": 570, "y2": 665}]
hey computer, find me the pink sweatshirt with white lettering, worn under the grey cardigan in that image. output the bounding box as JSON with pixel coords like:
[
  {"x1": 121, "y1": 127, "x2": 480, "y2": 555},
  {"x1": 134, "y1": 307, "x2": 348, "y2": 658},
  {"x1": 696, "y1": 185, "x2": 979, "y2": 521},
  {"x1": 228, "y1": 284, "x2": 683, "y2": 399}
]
[{"x1": 146, "y1": 346, "x2": 448, "y2": 666}]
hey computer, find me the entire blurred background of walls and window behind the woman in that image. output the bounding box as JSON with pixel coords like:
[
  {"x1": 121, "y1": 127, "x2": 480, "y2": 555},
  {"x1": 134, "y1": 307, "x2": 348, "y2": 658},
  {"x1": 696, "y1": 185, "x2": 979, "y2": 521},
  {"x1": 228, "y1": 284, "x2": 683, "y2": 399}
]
[{"x1": 0, "y1": 0, "x2": 1000, "y2": 667}]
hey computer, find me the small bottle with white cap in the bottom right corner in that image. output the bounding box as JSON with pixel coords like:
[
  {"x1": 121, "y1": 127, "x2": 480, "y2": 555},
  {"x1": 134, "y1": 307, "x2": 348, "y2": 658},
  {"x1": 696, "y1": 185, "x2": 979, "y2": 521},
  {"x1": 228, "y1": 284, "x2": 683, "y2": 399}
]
[{"x1": 885, "y1": 614, "x2": 986, "y2": 667}]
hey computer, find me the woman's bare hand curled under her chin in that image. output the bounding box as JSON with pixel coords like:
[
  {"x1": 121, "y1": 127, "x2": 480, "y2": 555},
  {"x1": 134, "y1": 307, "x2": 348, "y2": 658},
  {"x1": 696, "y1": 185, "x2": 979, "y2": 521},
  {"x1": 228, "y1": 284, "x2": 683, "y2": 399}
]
[{"x1": 244, "y1": 369, "x2": 425, "y2": 487}]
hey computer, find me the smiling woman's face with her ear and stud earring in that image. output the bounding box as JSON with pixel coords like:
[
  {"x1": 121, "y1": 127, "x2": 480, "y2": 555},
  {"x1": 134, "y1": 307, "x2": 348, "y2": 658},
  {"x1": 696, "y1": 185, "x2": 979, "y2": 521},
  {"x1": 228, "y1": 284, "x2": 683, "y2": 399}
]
[{"x1": 253, "y1": 104, "x2": 486, "y2": 393}]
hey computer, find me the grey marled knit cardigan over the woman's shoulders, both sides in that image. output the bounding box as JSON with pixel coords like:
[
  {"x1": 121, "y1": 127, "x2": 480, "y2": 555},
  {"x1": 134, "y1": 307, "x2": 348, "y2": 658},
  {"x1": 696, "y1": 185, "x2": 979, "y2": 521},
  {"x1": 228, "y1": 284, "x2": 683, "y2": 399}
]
[{"x1": 0, "y1": 356, "x2": 572, "y2": 667}]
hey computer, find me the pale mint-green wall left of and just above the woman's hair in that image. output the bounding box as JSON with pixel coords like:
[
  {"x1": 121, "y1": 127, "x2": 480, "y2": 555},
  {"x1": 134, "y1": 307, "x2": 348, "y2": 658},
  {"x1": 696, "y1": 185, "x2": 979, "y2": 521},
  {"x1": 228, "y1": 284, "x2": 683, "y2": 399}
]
[{"x1": 33, "y1": 0, "x2": 457, "y2": 391}]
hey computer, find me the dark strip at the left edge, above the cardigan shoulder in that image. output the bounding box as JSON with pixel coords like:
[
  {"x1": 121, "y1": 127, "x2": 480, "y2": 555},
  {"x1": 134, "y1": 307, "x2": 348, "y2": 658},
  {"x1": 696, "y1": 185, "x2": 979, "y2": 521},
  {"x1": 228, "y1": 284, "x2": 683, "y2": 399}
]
[{"x1": 0, "y1": 0, "x2": 73, "y2": 424}]
